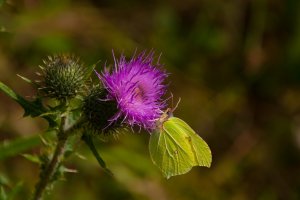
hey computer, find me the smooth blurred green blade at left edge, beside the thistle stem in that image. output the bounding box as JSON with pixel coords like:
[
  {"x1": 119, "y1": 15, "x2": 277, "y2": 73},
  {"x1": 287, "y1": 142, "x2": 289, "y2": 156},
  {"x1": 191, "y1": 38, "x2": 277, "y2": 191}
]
[{"x1": 0, "y1": 135, "x2": 41, "y2": 160}]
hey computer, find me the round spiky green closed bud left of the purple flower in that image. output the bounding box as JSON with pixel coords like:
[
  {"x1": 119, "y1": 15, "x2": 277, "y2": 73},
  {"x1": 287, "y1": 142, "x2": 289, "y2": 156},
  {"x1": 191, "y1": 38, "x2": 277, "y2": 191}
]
[{"x1": 38, "y1": 55, "x2": 87, "y2": 100}]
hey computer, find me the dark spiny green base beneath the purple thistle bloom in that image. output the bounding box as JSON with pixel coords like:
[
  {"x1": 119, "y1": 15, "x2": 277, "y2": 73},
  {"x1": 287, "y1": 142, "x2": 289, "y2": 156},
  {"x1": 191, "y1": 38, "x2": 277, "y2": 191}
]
[{"x1": 83, "y1": 86, "x2": 121, "y2": 134}]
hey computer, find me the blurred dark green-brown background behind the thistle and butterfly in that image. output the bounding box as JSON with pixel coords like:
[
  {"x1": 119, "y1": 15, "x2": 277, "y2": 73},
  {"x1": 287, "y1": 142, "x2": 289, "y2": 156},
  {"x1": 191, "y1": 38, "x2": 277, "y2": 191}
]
[{"x1": 0, "y1": 0, "x2": 300, "y2": 200}]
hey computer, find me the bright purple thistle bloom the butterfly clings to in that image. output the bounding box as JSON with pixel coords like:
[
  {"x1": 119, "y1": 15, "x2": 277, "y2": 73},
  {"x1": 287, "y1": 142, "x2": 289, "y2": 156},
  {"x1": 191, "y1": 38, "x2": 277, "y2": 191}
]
[{"x1": 97, "y1": 51, "x2": 167, "y2": 130}]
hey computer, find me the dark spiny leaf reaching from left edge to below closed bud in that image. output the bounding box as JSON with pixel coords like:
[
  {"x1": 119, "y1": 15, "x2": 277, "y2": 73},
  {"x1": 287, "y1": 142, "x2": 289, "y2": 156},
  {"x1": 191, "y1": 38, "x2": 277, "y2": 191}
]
[{"x1": 0, "y1": 81, "x2": 57, "y2": 127}]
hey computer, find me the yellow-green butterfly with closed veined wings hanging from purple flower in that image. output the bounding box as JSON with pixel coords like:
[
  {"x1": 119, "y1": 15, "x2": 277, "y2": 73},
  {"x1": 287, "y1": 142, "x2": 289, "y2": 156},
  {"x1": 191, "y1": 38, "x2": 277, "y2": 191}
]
[{"x1": 149, "y1": 117, "x2": 212, "y2": 178}]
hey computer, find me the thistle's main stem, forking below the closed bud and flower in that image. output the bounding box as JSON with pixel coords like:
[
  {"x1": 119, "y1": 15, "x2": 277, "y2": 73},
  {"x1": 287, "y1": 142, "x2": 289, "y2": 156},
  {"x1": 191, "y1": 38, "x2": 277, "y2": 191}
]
[{"x1": 32, "y1": 117, "x2": 82, "y2": 200}]
